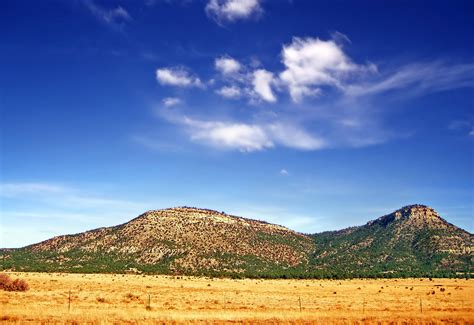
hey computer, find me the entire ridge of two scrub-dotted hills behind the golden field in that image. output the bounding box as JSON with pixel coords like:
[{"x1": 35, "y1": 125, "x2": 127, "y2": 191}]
[{"x1": 0, "y1": 205, "x2": 474, "y2": 278}]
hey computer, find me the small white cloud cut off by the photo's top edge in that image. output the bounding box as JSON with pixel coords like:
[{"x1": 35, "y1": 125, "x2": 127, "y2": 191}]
[{"x1": 205, "y1": 0, "x2": 262, "y2": 23}]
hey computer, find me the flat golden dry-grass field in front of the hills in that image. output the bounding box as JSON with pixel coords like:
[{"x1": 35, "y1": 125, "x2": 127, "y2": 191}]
[{"x1": 0, "y1": 273, "x2": 474, "y2": 324}]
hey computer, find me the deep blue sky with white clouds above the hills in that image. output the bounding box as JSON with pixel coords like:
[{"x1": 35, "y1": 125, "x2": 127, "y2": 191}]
[{"x1": 0, "y1": 0, "x2": 474, "y2": 247}]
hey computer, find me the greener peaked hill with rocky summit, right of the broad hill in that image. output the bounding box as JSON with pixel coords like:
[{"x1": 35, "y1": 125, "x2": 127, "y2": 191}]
[{"x1": 312, "y1": 205, "x2": 474, "y2": 277}]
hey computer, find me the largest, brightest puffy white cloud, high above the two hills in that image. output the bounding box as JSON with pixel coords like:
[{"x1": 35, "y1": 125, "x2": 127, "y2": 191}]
[{"x1": 280, "y1": 37, "x2": 372, "y2": 102}]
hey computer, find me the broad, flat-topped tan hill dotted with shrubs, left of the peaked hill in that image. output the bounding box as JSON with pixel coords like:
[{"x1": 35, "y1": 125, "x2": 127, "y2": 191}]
[{"x1": 0, "y1": 207, "x2": 314, "y2": 275}]
